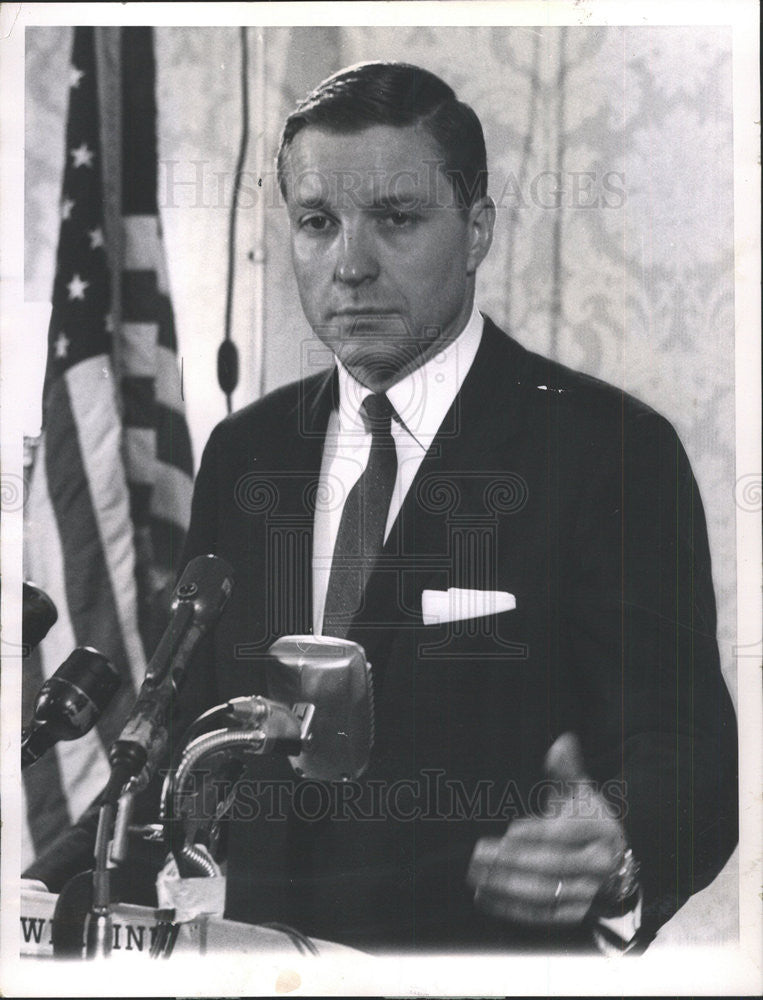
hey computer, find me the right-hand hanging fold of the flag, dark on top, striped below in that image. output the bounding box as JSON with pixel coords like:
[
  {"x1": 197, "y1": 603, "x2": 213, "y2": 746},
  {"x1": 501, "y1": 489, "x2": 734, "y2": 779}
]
[{"x1": 119, "y1": 28, "x2": 193, "y2": 648}]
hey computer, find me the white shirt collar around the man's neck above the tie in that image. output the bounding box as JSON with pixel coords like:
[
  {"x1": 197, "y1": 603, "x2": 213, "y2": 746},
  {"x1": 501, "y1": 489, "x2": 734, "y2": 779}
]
[{"x1": 336, "y1": 306, "x2": 484, "y2": 451}]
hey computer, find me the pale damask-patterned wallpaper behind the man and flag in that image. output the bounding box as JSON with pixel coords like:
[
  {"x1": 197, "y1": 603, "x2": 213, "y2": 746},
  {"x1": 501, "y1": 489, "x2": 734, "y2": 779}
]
[{"x1": 26, "y1": 27, "x2": 736, "y2": 933}]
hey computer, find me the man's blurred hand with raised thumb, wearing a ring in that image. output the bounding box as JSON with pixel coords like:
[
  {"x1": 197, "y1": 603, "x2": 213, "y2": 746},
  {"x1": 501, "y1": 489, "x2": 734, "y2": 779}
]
[{"x1": 467, "y1": 733, "x2": 626, "y2": 925}]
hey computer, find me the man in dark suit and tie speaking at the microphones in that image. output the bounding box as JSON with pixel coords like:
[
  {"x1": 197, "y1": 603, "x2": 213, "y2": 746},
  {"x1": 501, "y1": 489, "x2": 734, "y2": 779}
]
[{"x1": 26, "y1": 63, "x2": 736, "y2": 950}]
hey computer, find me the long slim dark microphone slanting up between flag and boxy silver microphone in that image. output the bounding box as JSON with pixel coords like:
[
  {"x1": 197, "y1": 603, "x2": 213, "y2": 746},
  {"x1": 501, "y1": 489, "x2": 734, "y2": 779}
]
[{"x1": 109, "y1": 555, "x2": 233, "y2": 787}]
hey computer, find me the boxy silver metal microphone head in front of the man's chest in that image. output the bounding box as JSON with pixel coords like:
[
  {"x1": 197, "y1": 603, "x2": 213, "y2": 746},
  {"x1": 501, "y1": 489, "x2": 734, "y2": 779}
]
[{"x1": 267, "y1": 635, "x2": 374, "y2": 781}]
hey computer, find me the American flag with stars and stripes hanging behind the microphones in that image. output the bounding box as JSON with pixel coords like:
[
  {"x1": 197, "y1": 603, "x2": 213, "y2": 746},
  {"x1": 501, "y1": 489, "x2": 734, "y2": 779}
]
[{"x1": 22, "y1": 27, "x2": 193, "y2": 865}]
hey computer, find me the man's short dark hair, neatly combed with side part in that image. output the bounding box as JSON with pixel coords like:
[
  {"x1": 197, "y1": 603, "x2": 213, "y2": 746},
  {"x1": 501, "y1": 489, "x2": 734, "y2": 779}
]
[{"x1": 276, "y1": 62, "x2": 487, "y2": 209}]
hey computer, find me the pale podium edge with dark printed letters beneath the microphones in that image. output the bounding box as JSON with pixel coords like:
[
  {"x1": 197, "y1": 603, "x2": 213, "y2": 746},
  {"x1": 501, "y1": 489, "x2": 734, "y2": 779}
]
[{"x1": 20, "y1": 889, "x2": 361, "y2": 961}]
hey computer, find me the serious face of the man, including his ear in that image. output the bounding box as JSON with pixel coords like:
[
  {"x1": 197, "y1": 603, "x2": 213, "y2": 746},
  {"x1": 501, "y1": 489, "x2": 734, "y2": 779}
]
[{"x1": 286, "y1": 125, "x2": 494, "y2": 392}]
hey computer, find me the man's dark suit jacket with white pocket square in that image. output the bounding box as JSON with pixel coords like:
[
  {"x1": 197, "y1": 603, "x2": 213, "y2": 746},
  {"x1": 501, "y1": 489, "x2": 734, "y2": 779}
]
[{"x1": 29, "y1": 320, "x2": 737, "y2": 950}]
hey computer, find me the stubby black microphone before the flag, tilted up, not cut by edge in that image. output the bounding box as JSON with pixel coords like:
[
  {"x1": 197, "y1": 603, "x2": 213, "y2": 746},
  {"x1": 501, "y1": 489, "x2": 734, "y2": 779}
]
[{"x1": 21, "y1": 646, "x2": 121, "y2": 768}]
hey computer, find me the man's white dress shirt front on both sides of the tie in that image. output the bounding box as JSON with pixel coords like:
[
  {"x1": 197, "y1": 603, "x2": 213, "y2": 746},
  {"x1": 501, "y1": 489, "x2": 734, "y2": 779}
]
[{"x1": 313, "y1": 307, "x2": 484, "y2": 635}]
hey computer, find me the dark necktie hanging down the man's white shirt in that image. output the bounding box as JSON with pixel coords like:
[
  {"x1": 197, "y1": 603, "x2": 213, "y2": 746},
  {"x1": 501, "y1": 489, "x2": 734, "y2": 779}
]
[{"x1": 323, "y1": 393, "x2": 397, "y2": 639}]
